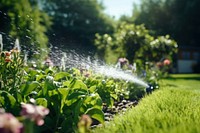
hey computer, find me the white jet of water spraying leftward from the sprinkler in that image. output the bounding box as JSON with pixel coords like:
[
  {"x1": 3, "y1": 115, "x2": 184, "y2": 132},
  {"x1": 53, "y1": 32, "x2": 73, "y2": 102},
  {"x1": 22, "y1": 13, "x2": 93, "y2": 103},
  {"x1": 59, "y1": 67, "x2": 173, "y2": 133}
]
[{"x1": 50, "y1": 51, "x2": 149, "y2": 88}]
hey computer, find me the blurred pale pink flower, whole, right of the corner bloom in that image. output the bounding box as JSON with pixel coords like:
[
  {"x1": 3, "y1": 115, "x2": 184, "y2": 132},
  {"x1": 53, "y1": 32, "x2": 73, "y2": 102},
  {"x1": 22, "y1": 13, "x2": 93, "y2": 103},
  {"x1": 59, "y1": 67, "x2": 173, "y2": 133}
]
[{"x1": 21, "y1": 104, "x2": 49, "y2": 126}]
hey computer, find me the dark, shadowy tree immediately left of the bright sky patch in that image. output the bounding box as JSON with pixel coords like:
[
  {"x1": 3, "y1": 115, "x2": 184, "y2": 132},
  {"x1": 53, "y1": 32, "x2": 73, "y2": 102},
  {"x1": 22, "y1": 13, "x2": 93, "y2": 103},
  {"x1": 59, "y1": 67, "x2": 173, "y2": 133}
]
[{"x1": 43, "y1": 0, "x2": 113, "y2": 51}]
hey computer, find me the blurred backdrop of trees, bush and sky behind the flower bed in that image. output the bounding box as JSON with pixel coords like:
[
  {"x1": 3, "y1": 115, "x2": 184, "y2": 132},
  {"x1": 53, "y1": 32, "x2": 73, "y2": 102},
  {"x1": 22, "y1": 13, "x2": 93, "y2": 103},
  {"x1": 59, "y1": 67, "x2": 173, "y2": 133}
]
[{"x1": 0, "y1": 0, "x2": 200, "y2": 73}]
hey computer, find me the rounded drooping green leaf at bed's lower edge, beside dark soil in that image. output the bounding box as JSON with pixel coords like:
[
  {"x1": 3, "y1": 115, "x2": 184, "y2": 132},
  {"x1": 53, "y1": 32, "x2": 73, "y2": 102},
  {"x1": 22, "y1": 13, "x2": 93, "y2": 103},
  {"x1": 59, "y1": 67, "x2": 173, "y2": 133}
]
[{"x1": 85, "y1": 108, "x2": 105, "y2": 123}]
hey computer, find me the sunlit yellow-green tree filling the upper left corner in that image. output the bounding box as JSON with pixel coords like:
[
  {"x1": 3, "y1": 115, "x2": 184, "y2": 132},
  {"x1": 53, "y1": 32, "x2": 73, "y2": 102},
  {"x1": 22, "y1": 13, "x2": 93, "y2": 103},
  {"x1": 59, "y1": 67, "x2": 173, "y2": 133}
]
[{"x1": 0, "y1": 0, "x2": 51, "y2": 57}]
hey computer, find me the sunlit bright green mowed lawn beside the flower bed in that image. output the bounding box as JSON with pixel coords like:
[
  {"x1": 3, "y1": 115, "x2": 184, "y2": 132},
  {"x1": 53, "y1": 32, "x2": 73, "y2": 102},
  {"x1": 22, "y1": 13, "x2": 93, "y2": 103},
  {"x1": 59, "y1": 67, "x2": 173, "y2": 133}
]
[{"x1": 93, "y1": 74, "x2": 200, "y2": 133}]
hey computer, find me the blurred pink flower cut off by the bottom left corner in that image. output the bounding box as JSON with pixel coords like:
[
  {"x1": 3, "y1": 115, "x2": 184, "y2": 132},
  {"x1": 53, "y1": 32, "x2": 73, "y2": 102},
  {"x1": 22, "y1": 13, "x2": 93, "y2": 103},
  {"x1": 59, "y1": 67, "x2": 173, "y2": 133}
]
[{"x1": 0, "y1": 113, "x2": 23, "y2": 133}]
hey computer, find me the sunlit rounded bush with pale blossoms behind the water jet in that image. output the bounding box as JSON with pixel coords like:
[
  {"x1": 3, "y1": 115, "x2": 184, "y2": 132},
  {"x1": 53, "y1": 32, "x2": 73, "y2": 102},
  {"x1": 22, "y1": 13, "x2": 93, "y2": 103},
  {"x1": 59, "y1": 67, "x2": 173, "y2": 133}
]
[{"x1": 95, "y1": 22, "x2": 177, "y2": 65}]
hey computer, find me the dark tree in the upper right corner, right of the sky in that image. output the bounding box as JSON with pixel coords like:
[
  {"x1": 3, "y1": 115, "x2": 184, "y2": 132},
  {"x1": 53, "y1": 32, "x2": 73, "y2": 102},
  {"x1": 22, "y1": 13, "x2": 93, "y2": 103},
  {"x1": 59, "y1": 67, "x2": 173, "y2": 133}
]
[{"x1": 132, "y1": 0, "x2": 200, "y2": 46}]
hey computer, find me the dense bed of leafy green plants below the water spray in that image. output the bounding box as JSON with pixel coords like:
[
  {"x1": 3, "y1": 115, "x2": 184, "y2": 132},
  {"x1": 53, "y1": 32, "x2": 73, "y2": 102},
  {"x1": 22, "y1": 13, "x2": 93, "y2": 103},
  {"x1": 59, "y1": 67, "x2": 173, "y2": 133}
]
[{"x1": 0, "y1": 49, "x2": 145, "y2": 132}]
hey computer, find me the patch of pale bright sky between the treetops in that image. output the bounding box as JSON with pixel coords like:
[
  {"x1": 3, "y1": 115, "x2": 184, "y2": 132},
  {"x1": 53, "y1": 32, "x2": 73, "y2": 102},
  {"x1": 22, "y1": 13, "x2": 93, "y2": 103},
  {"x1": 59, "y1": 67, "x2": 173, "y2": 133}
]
[{"x1": 103, "y1": 0, "x2": 140, "y2": 19}]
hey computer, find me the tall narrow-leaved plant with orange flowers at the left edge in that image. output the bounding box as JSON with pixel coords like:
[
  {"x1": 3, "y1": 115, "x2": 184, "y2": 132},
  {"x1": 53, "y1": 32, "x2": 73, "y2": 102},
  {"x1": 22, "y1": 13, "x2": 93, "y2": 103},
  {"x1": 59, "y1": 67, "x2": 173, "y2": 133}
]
[{"x1": 0, "y1": 49, "x2": 23, "y2": 106}]
